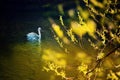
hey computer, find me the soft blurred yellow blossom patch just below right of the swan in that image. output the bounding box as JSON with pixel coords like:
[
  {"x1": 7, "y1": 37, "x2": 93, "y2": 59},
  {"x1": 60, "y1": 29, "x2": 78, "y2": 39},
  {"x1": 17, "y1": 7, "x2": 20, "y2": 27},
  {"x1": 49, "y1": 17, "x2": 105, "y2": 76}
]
[{"x1": 42, "y1": 49, "x2": 66, "y2": 66}]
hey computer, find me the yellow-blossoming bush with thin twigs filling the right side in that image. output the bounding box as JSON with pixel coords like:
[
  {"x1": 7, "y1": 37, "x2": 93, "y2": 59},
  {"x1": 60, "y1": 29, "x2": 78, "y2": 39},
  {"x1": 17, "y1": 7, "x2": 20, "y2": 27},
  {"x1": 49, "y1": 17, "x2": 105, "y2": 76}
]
[{"x1": 42, "y1": 0, "x2": 120, "y2": 80}]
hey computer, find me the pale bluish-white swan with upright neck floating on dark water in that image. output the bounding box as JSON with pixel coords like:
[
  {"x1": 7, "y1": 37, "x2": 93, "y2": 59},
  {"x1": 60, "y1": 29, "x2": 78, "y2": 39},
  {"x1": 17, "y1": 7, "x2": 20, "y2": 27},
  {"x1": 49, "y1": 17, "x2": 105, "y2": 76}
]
[{"x1": 27, "y1": 27, "x2": 41, "y2": 44}]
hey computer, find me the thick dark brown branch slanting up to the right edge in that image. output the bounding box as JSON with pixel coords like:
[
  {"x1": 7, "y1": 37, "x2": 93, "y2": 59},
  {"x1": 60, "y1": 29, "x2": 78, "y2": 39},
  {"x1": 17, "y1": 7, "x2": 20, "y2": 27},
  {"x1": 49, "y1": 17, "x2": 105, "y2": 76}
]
[{"x1": 87, "y1": 44, "x2": 120, "y2": 74}]
